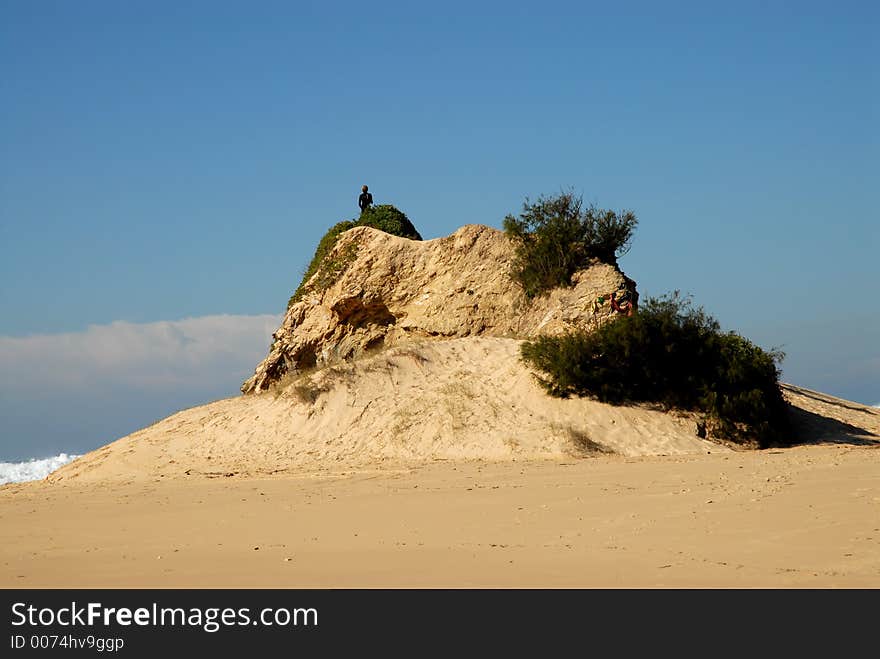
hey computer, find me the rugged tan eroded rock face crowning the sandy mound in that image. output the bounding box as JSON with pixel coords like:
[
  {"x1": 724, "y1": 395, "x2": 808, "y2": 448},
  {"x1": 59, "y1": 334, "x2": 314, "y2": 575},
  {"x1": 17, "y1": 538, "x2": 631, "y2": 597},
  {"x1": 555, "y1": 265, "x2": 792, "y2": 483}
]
[{"x1": 241, "y1": 224, "x2": 637, "y2": 393}]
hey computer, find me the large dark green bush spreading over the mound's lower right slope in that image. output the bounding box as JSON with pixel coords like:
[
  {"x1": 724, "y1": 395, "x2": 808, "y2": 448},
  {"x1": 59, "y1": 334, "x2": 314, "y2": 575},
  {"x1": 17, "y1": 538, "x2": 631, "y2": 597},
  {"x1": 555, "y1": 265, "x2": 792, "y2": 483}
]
[{"x1": 521, "y1": 292, "x2": 787, "y2": 446}]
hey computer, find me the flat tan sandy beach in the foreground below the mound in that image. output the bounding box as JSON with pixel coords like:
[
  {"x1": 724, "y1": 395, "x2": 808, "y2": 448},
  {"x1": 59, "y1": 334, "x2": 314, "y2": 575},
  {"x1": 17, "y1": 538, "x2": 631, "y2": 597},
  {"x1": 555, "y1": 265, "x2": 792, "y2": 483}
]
[{"x1": 0, "y1": 444, "x2": 880, "y2": 588}]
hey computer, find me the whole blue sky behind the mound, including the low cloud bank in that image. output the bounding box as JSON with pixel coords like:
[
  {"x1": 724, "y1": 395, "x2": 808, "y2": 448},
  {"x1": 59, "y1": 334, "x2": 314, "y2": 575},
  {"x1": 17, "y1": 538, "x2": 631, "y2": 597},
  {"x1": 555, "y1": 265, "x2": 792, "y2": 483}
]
[{"x1": 0, "y1": 0, "x2": 880, "y2": 461}]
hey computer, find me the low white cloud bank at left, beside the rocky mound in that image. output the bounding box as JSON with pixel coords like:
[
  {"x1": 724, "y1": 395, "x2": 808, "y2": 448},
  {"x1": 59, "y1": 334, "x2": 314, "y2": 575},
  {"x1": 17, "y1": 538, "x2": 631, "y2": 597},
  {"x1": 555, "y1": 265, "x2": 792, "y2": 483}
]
[{"x1": 0, "y1": 314, "x2": 281, "y2": 392}]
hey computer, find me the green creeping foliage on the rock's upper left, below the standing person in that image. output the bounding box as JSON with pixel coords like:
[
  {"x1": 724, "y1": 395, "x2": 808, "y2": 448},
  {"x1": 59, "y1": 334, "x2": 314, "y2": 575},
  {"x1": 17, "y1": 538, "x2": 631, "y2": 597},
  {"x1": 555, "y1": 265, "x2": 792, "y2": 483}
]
[{"x1": 287, "y1": 204, "x2": 422, "y2": 309}]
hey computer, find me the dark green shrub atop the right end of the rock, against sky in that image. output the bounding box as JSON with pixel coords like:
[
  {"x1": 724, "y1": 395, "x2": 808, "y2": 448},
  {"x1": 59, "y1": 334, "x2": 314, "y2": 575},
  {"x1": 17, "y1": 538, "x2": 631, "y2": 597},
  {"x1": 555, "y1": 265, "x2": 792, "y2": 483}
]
[{"x1": 504, "y1": 192, "x2": 638, "y2": 298}]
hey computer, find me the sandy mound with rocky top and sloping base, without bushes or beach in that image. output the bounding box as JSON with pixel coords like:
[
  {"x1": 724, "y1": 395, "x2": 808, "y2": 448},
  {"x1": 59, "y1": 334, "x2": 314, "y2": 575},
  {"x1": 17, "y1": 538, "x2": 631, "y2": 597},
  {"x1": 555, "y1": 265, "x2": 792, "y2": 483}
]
[{"x1": 49, "y1": 225, "x2": 880, "y2": 483}]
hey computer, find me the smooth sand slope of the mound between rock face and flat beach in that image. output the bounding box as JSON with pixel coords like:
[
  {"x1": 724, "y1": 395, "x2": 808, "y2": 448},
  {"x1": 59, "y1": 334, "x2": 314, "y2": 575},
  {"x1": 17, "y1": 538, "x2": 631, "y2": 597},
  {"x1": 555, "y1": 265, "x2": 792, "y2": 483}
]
[{"x1": 51, "y1": 337, "x2": 722, "y2": 482}]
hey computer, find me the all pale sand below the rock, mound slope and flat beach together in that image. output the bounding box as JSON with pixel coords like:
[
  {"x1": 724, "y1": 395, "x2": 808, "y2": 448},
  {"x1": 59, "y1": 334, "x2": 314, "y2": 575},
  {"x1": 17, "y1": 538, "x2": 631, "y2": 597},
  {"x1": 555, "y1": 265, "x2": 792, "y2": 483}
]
[{"x1": 0, "y1": 339, "x2": 880, "y2": 588}]
